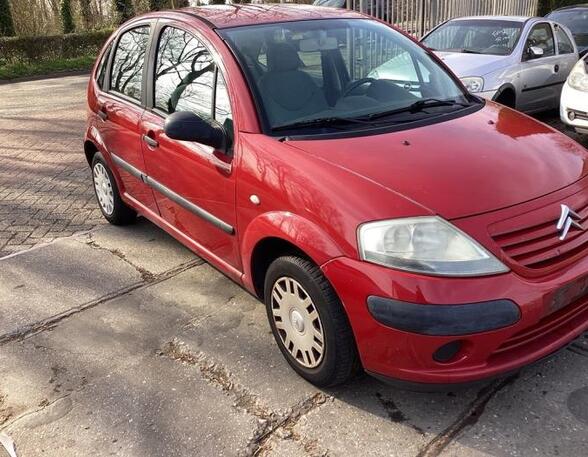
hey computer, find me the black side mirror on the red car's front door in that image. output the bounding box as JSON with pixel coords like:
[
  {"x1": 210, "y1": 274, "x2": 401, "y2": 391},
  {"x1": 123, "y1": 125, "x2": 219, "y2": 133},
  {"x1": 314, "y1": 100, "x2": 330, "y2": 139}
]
[{"x1": 164, "y1": 111, "x2": 227, "y2": 150}]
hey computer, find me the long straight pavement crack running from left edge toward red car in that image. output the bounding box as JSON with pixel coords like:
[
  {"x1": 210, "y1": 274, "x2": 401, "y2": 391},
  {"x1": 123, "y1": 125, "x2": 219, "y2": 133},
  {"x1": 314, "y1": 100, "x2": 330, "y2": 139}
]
[{"x1": 0, "y1": 258, "x2": 203, "y2": 346}]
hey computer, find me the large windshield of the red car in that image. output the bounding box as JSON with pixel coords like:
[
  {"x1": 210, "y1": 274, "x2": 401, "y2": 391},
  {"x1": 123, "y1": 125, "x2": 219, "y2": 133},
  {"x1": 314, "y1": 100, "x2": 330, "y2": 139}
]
[{"x1": 221, "y1": 19, "x2": 480, "y2": 134}]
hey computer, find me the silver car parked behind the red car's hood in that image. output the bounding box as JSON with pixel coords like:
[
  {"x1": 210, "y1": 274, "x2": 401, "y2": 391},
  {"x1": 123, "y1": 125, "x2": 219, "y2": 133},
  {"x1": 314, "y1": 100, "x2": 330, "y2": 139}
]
[{"x1": 422, "y1": 16, "x2": 579, "y2": 113}]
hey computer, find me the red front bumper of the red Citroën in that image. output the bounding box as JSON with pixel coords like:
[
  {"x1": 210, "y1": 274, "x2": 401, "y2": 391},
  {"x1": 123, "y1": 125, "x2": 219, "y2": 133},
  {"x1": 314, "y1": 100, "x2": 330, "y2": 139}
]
[{"x1": 322, "y1": 258, "x2": 588, "y2": 384}]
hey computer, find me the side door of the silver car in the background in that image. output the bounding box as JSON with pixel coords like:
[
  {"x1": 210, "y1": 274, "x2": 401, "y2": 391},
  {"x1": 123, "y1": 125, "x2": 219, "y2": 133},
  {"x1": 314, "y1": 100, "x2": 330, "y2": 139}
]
[{"x1": 517, "y1": 22, "x2": 561, "y2": 111}]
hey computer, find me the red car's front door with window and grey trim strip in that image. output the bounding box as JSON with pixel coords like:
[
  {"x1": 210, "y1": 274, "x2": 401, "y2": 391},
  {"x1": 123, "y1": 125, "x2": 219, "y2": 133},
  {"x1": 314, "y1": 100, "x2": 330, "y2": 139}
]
[{"x1": 142, "y1": 26, "x2": 241, "y2": 270}]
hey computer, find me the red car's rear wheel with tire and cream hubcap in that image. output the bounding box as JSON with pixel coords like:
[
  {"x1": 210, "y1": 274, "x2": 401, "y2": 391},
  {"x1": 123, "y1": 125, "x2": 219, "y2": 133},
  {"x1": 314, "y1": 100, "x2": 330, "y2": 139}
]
[{"x1": 92, "y1": 152, "x2": 137, "y2": 225}]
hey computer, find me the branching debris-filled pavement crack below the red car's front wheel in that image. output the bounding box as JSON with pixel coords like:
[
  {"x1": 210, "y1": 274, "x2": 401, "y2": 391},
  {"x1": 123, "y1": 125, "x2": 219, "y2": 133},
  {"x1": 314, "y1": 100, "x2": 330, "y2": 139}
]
[{"x1": 158, "y1": 339, "x2": 332, "y2": 457}]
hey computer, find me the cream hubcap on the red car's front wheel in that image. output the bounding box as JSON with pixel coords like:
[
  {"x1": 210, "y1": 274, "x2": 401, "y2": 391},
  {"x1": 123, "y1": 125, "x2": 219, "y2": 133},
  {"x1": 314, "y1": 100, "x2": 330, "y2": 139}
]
[{"x1": 271, "y1": 276, "x2": 325, "y2": 368}]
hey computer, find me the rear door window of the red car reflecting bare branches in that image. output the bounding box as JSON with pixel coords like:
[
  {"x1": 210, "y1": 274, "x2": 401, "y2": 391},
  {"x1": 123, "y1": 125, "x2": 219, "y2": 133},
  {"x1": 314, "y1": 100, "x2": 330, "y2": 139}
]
[{"x1": 110, "y1": 26, "x2": 149, "y2": 101}]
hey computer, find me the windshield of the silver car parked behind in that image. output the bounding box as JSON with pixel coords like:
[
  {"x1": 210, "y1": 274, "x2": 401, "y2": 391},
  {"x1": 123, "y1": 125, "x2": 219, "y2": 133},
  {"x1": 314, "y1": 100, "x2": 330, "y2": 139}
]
[{"x1": 423, "y1": 19, "x2": 523, "y2": 56}]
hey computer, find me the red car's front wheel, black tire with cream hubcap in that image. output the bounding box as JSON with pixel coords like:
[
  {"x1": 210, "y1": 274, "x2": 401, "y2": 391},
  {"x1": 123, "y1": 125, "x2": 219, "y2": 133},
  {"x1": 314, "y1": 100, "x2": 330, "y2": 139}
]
[{"x1": 264, "y1": 256, "x2": 360, "y2": 387}]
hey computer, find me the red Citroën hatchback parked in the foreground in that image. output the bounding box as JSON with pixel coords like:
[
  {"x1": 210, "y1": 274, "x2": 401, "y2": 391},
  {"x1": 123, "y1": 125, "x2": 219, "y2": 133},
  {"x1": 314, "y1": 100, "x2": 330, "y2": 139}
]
[{"x1": 85, "y1": 5, "x2": 588, "y2": 386}]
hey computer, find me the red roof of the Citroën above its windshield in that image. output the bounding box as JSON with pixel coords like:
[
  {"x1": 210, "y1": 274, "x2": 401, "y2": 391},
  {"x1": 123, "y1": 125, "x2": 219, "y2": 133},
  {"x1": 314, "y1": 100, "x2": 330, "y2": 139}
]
[{"x1": 168, "y1": 3, "x2": 366, "y2": 29}]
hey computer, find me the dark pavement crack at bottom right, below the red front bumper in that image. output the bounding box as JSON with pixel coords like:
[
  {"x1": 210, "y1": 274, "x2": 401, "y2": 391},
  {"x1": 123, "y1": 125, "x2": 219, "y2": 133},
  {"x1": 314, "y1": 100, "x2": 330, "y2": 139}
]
[{"x1": 417, "y1": 373, "x2": 519, "y2": 457}]
